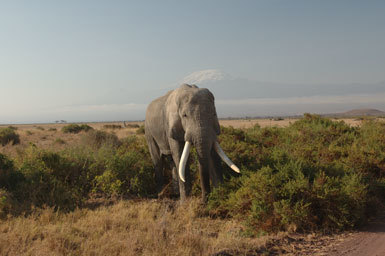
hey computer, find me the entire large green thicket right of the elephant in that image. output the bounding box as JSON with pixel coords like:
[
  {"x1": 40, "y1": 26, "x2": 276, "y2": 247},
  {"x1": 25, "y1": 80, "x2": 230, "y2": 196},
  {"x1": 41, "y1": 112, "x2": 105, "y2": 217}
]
[{"x1": 209, "y1": 114, "x2": 385, "y2": 234}]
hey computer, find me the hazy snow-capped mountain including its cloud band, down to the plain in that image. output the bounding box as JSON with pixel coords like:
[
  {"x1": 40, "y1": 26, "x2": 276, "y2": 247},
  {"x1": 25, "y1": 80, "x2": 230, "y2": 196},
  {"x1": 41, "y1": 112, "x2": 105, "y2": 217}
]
[{"x1": 176, "y1": 69, "x2": 385, "y2": 117}]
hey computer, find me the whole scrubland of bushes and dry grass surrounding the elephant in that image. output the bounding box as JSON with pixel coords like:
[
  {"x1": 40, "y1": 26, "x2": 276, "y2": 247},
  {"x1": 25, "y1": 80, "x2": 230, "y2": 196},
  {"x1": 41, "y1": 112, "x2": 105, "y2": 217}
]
[{"x1": 0, "y1": 114, "x2": 385, "y2": 255}]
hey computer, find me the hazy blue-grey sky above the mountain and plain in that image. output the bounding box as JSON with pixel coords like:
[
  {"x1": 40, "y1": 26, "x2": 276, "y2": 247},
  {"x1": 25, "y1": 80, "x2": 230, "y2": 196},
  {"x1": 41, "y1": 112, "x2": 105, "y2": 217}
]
[{"x1": 0, "y1": 0, "x2": 385, "y2": 124}]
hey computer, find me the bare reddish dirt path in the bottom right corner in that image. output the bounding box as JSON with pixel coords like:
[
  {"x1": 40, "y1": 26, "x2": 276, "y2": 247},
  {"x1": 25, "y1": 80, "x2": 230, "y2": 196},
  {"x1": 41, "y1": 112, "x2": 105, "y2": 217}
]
[{"x1": 323, "y1": 212, "x2": 385, "y2": 256}]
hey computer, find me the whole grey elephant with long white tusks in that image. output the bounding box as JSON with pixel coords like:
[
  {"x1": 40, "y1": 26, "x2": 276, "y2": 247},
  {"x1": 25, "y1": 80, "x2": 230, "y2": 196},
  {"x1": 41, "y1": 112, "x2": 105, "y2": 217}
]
[{"x1": 145, "y1": 84, "x2": 239, "y2": 201}]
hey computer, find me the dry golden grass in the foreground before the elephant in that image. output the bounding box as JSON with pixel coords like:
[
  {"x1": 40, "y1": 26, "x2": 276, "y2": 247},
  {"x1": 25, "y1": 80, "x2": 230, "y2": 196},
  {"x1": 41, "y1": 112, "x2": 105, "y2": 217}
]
[{"x1": 0, "y1": 199, "x2": 270, "y2": 255}]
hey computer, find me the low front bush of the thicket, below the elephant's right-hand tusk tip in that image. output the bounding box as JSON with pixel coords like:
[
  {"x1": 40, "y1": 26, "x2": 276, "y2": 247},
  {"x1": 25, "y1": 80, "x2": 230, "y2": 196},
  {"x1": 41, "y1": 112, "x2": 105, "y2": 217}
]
[{"x1": 208, "y1": 165, "x2": 368, "y2": 232}]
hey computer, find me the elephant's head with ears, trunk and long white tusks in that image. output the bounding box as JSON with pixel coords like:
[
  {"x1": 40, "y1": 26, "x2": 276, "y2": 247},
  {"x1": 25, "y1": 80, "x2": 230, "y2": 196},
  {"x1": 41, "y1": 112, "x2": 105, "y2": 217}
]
[{"x1": 167, "y1": 84, "x2": 239, "y2": 198}]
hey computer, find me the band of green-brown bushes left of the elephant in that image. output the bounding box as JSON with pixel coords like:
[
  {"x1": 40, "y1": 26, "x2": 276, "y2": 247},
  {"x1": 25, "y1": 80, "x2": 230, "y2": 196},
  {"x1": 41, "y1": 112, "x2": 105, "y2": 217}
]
[{"x1": 0, "y1": 133, "x2": 155, "y2": 214}]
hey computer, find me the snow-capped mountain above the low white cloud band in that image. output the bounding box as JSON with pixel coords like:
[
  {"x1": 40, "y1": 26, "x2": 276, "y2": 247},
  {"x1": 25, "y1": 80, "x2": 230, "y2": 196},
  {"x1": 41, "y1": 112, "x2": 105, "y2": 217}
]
[{"x1": 181, "y1": 69, "x2": 385, "y2": 99}]
